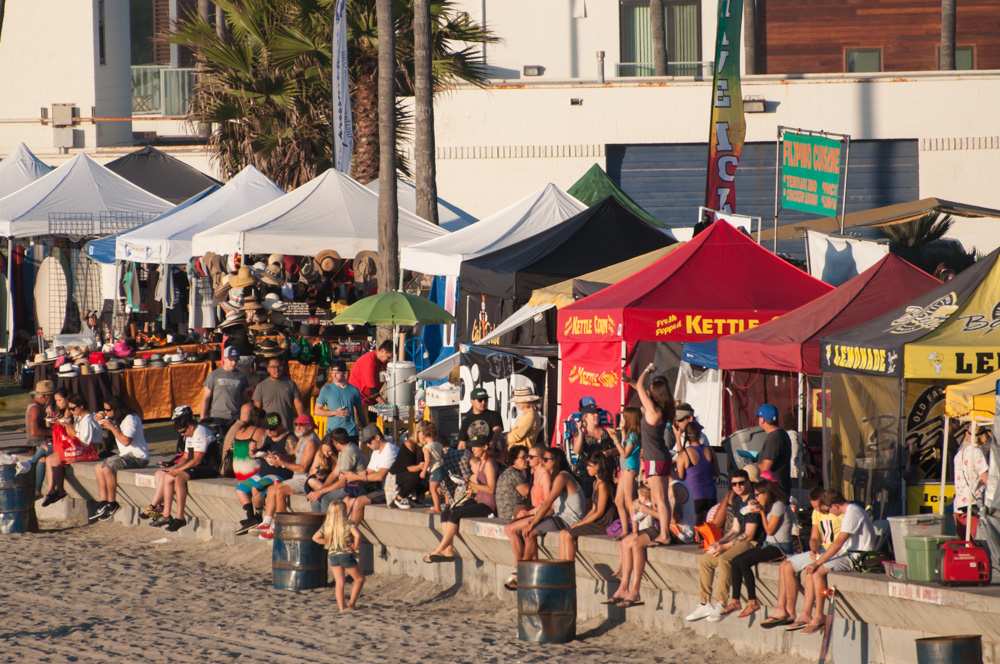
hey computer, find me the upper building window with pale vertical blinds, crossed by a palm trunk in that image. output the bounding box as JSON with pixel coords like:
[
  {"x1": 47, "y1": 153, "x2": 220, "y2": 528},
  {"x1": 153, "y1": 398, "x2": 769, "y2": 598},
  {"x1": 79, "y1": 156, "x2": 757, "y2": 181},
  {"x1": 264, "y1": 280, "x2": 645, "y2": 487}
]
[{"x1": 618, "y1": 0, "x2": 701, "y2": 76}]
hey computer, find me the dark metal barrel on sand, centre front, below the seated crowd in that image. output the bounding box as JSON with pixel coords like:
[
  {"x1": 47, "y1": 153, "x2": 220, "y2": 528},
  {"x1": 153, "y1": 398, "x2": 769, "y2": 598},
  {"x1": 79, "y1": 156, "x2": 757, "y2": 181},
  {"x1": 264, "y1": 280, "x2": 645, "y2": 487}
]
[{"x1": 517, "y1": 560, "x2": 576, "y2": 643}]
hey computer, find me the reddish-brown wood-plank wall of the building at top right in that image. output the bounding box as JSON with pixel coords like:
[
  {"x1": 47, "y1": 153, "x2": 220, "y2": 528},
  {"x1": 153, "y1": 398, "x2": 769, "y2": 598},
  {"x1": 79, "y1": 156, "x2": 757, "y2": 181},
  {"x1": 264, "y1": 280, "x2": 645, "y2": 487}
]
[{"x1": 757, "y1": 0, "x2": 1000, "y2": 74}]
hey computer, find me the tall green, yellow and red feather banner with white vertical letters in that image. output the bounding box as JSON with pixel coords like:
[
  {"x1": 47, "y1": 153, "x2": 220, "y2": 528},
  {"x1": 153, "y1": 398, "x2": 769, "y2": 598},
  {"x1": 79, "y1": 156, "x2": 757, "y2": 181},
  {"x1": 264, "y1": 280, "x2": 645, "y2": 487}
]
[{"x1": 705, "y1": 0, "x2": 747, "y2": 212}]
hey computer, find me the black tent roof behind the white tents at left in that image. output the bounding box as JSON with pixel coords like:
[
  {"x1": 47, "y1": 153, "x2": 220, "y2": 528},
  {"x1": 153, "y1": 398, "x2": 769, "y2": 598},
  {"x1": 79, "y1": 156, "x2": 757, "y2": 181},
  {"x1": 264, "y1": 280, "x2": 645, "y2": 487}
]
[{"x1": 105, "y1": 146, "x2": 222, "y2": 203}]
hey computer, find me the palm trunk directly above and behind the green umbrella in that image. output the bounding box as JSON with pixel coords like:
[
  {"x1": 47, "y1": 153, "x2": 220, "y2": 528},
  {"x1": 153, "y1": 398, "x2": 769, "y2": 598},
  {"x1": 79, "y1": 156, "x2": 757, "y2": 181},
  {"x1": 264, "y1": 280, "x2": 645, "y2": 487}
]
[{"x1": 375, "y1": 0, "x2": 399, "y2": 306}]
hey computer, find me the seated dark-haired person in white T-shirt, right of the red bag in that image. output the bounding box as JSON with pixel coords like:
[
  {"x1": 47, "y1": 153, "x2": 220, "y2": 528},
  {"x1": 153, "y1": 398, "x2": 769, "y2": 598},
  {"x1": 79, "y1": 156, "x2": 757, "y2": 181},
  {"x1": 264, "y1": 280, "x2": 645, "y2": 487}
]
[{"x1": 90, "y1": 396, "x2": 149, "y2": 521}]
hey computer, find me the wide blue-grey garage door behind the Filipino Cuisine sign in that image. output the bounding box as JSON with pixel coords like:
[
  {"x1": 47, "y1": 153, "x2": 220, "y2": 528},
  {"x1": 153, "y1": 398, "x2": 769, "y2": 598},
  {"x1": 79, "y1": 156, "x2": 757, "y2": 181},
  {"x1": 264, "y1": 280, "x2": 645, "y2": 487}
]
[{"x1": 607, "y1": 140, "x2": 919, "y2": 228}]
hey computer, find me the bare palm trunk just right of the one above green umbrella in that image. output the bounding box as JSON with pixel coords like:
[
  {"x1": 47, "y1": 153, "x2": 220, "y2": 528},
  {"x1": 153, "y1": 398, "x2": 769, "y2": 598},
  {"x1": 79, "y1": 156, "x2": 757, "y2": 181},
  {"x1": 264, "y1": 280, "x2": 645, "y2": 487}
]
[{"x1": 413, "y1": 0, "x2": 439, "y2": 224}]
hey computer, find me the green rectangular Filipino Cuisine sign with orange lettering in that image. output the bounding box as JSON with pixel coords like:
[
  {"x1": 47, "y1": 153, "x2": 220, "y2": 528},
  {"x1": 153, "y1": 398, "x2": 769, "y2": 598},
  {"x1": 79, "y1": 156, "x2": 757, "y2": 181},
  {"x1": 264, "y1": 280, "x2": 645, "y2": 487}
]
[{"x1": 780, "y1": 131, "x2": 843, "y2": 217}]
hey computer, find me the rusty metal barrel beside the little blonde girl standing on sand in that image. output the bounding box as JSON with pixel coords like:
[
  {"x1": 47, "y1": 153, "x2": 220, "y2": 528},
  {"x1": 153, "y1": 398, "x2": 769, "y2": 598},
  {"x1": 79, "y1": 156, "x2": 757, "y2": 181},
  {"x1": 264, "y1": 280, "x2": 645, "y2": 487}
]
[{"x1": 271, "y1": 513, "x2": 327, "y2": 590}]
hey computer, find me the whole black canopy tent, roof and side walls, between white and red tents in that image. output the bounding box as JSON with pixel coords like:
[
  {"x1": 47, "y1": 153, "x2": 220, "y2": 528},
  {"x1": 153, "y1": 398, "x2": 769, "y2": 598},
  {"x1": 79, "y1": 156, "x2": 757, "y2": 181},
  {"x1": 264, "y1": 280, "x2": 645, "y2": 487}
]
[{"x1": 456, "y1": 197, "x2": 674, "y2": 344}]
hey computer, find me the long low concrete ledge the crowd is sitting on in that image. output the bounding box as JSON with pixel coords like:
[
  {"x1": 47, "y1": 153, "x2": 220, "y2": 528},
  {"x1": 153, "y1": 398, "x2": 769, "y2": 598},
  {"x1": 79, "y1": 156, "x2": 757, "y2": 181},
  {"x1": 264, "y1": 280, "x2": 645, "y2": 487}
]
[{"x1": 56, "y1": 459, "x2": 1000, "y2": 664}]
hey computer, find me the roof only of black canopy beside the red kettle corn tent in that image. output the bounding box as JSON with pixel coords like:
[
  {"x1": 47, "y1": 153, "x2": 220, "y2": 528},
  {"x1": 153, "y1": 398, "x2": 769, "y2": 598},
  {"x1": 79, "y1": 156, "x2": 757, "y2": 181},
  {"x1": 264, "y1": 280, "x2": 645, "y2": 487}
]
[{"x1": 460, "y1": 196, "x2": 673, "y2": 299}]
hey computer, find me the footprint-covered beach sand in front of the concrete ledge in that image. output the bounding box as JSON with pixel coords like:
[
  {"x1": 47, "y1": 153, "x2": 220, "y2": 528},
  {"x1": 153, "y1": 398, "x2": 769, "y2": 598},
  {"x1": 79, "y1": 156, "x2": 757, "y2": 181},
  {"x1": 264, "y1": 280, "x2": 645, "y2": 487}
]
[{"x1": 0, "y1": 523, "x2": 801, "y2": 664}]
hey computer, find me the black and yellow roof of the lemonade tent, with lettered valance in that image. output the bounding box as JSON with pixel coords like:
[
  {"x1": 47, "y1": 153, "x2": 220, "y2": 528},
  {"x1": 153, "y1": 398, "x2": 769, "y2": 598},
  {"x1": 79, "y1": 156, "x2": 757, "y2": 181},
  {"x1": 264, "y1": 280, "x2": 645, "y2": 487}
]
[{"x1": 820, "y1": 250, "x2": 1000, "y2": 380}]
